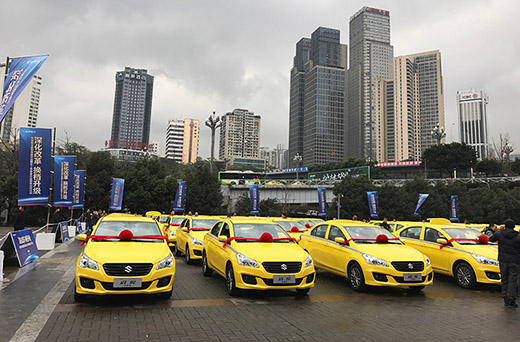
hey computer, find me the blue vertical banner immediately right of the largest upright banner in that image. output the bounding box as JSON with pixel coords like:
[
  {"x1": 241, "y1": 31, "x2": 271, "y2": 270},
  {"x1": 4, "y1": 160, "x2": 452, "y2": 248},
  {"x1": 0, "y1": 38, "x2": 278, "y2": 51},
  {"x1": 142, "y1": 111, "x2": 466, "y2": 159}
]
[{"x1": 53, "y1": 156, "x2": 76, "y2": 207}]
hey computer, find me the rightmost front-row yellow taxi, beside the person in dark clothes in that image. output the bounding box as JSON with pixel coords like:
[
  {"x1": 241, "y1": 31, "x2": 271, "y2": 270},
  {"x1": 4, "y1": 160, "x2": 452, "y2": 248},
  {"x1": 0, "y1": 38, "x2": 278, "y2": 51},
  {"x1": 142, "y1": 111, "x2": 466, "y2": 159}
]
[{"x1": 395, "y1": 219, "x2": 500, "y2": 288}]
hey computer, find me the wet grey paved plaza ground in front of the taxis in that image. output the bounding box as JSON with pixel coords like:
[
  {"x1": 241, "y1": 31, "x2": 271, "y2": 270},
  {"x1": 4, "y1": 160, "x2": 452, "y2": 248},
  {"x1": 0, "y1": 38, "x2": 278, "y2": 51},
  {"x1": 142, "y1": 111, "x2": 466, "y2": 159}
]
[{"x1": 0, "y1": 236, "x2": 520, "y2": 341}]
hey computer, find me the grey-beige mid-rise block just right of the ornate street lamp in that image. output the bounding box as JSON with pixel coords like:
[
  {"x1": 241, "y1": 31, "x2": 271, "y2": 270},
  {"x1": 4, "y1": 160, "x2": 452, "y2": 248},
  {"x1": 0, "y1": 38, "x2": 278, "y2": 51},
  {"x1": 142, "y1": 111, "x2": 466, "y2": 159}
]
[{"x1": 219, "y1": 109, "x2": 261, "y2": 160}]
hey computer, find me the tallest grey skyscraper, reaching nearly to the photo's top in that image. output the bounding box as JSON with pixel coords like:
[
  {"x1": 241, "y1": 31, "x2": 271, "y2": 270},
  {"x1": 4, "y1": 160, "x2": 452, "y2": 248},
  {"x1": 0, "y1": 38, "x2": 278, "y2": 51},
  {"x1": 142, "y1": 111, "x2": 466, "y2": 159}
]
[{"x1": 345, "y1": 7, "x2": 393, "y2": 160}]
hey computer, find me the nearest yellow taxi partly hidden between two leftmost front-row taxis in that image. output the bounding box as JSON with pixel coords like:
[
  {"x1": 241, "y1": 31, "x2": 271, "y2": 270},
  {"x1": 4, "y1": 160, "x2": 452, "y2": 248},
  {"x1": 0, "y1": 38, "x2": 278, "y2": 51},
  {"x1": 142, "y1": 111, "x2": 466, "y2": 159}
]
[{"x1": 174, "y1": 216, "x2": 220, "y2": 265}]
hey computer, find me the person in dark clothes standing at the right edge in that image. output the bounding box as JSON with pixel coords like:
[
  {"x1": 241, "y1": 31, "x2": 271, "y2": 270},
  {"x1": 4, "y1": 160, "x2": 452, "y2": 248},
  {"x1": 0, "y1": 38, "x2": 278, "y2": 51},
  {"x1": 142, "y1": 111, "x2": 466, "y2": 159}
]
[{"x1": 489, "y1": 219, "x2": 520, "y2": 308}]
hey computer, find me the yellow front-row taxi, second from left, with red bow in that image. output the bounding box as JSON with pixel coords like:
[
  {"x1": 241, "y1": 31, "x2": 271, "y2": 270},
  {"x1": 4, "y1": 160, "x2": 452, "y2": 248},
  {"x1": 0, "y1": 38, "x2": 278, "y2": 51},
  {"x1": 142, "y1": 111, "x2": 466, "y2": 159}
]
[{"x1": 202, "y1": 218, "x2": 315, "y2": 296}]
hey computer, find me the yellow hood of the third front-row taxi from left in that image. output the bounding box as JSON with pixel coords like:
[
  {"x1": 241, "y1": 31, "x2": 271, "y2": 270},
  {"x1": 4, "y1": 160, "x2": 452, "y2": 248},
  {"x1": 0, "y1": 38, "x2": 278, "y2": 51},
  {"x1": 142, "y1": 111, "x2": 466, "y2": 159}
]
[{"x1": 352, "y1": 243, "x2": 424, "y2": 262}]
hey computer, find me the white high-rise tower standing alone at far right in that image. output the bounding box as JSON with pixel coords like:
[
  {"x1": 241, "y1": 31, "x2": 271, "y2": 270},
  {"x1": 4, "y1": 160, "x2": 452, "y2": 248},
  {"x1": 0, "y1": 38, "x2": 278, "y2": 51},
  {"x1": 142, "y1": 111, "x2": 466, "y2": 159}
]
[{"x1": 457, "y1": 89, "x2": 489, "y2": 160}]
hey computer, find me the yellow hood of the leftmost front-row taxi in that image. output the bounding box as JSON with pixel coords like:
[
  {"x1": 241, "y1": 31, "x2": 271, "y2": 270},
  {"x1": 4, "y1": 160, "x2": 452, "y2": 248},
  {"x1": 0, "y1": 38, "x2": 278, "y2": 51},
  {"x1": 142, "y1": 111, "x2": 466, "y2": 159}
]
[{"x1": 84, "y1": 241, "x2": 171, "y2": 264}]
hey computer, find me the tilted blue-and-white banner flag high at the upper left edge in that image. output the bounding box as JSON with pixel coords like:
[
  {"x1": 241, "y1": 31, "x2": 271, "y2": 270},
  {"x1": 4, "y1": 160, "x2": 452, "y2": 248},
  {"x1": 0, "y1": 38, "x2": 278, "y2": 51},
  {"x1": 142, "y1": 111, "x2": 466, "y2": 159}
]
[{"x1": 0, "y1": 55, "x2": 49, "y2": 122}]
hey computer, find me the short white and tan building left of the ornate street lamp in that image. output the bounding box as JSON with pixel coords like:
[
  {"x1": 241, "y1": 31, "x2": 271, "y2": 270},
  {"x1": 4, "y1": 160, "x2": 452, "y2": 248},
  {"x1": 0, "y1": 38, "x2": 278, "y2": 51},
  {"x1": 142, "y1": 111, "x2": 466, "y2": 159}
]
[{"x1": 166, "y1": 119, "x2": 199, "y2": 164}]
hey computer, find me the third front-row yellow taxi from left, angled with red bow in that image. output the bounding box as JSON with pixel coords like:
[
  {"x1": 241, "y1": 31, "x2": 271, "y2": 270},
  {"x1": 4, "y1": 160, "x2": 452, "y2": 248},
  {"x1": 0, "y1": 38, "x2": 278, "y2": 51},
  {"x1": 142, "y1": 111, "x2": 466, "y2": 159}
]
[{"x1": 300, "y1": 220, "x2": 433, "y2": 291}]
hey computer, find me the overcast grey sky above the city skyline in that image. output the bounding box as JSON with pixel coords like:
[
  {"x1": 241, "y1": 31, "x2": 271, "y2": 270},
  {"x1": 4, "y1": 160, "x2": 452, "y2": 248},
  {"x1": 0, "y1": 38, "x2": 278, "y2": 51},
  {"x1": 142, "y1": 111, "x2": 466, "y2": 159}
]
[{"x1": 0, "y1": 0, "x2": 520, "y2": 157}]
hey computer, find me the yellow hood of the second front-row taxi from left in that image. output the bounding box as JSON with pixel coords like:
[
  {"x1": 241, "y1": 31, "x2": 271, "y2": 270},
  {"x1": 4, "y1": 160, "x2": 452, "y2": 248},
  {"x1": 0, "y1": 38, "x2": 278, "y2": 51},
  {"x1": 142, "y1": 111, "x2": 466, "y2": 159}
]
[{"x1": 231, "y1": 241, "x2": 308, "y2": 263}]
